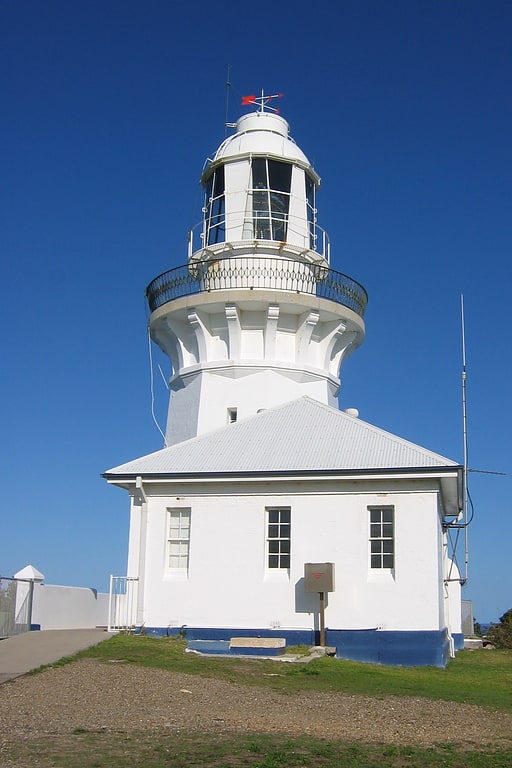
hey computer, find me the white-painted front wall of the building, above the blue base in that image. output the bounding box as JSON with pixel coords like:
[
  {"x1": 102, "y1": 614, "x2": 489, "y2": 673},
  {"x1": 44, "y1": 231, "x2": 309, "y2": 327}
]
[{"x1": 132, "y1": 480, "x2": 445, "y2": 630}]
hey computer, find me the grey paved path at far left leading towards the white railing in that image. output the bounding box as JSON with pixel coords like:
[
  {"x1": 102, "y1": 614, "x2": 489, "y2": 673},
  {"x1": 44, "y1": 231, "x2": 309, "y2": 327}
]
[{"x1": 0, "y1": 629, "x2": 112, "y2": 683}]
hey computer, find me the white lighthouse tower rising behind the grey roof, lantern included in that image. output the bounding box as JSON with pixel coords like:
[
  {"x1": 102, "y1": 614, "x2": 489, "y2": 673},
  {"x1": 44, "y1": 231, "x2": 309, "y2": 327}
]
[{"x1": 146, "y1": 96, "x2": 367, "y2": 445}]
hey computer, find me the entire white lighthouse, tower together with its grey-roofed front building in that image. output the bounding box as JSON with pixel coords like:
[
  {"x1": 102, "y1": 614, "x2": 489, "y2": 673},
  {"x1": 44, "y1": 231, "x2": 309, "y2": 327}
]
[{"x1": 105, "y1": 97, "x2": 461, "y2": 666}]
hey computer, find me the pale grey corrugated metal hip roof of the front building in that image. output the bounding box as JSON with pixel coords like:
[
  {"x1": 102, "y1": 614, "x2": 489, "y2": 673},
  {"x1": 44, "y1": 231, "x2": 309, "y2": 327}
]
[{"x1": 105, "y1": 397, "x2": 459, "y2": 477}]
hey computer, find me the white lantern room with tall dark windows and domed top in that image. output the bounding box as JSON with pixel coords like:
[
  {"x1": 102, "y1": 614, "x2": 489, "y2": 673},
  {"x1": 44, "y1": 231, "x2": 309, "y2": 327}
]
[{"x1": 190, "y1": 111, "x2": 329, "y2": 262}]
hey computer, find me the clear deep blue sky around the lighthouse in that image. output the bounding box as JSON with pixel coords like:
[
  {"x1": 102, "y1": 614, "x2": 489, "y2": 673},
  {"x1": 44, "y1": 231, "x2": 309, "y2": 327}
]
[{"x1": 0, "y1": 0, "x2": 512, "y2": 622}]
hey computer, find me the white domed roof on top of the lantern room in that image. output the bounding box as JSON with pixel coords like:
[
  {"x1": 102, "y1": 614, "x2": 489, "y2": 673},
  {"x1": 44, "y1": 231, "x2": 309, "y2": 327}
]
[{"x1": 213, "y1": 112, "x2": 310, "y2": 167}]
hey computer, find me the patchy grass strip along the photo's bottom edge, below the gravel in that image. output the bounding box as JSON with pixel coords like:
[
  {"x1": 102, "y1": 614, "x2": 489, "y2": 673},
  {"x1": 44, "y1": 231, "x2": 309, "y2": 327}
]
[{"x1": 3, "y1": 729, "x2": 512, "y2": 768}]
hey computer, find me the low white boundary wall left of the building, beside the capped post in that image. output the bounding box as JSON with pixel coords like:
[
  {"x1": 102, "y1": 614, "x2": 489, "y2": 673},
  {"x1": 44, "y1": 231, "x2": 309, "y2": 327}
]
[{"x1": 32, "y1": 583, "x2": 109, "y2": 629}]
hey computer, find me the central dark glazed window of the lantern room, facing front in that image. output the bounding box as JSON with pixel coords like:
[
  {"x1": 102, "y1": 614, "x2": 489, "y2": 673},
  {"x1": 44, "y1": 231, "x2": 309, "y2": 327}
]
[{"x1": 252, "y1": 157, "x2": 292, "y2": 242}]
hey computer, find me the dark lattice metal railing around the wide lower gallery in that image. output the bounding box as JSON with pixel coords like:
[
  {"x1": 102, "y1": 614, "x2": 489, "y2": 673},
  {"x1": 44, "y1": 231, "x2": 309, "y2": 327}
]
[{"x1": 146, "y1": 256, "x2": 368, "y2": 317}]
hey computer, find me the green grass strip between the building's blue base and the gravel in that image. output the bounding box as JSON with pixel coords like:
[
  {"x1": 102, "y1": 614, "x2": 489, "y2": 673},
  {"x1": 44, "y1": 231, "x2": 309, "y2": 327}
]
[{"x1": 78, "y1": 634, "x2": 512, "y2": 711}]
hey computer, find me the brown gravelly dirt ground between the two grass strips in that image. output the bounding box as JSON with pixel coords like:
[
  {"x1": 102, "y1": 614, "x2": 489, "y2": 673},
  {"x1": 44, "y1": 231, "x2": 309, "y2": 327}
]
[{"x1": 0, "y1": 659, "x2": 512, "y2": 746}]
